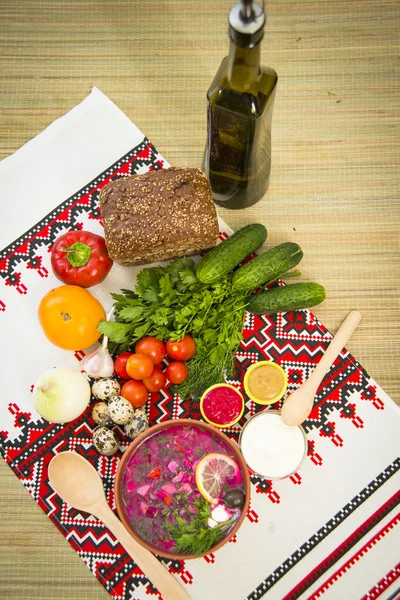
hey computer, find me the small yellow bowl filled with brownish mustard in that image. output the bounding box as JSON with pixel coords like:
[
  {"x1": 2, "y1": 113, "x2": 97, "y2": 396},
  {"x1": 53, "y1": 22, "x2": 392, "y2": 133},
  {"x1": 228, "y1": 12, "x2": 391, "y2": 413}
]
[{"x1": 243, "y1": 360, "x2": 287, "y2": 405}]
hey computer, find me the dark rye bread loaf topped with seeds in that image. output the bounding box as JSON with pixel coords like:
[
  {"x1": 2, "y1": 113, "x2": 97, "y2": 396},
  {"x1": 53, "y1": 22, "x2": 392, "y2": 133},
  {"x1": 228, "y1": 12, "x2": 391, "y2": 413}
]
[{"x1": 100, "y1": 167, "x2": 218, "y2": 265}]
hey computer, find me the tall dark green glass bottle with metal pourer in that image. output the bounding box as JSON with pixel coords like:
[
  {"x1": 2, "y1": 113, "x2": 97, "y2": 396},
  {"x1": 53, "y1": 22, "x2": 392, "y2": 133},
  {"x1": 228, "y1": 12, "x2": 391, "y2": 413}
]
[{"x1": 203, "y1": 0, "x2": 278, "y2": 209}]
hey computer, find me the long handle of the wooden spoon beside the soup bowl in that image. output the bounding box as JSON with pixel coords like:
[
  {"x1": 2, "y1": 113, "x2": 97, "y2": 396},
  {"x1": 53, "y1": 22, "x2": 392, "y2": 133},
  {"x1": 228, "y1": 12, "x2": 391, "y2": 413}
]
[{"x1": 94, "y1": 502, "x2": 190, "y2": 600}]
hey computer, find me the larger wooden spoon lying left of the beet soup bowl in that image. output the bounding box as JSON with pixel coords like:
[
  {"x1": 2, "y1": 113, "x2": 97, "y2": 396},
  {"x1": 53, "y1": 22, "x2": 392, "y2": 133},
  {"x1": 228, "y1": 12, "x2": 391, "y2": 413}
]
[{"x1": 49, "y1": 452, "x2": 190, "y2": 600}]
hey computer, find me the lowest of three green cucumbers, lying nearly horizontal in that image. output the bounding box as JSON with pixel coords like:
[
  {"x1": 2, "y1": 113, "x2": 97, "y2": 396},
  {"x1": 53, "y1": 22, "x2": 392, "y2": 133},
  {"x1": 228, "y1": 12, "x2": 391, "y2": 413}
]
[{"x1": 246, "y1": 283, "x2": 326, "y2": 315}]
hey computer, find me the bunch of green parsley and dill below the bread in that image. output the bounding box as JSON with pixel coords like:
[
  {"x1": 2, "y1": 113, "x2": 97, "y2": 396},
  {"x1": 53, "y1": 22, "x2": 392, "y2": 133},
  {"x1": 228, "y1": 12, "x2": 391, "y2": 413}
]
[{"x1": 99, "y1": 257, "x2": 248, "y2": 398}]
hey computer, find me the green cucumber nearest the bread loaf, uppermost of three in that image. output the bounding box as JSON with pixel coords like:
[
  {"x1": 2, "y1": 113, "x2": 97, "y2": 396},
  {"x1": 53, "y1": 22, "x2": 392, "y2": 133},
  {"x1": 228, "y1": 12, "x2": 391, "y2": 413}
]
[{"x1": 196, "y1": 223, "x2": 267, "y2": 283}]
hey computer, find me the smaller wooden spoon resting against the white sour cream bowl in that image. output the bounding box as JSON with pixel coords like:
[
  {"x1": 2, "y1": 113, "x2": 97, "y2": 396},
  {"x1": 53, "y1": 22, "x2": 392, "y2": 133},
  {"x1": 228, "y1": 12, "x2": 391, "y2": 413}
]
[{"x1": 281, "y1": 310, "x2": 361, "y2": 425}]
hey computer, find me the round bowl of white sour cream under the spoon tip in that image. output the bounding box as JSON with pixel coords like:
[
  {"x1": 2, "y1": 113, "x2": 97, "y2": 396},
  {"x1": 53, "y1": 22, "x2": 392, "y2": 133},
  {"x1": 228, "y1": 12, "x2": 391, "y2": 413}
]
[{"x1": 239, "y1": 410, "x2": 307, "y2": 479}]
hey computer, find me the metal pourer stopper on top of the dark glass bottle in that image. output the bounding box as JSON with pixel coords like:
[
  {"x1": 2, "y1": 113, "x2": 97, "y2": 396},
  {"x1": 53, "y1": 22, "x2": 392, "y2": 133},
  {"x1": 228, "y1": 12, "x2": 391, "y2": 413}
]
[{"x1": 228, "y1": 0, "x2": 266, "y2": 48}]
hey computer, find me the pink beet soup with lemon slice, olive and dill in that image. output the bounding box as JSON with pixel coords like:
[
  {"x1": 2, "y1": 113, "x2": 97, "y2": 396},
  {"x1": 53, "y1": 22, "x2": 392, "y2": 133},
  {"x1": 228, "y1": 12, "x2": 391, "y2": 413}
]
[{"x1": 122, "y1": 425, "x2": 245, "y2": 555}]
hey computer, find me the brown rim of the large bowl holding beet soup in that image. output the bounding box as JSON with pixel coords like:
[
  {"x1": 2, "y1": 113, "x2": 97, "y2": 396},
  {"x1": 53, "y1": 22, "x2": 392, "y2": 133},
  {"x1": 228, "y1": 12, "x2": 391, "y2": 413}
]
[{"x1": 114, "y1": 418, "x2": 251, "y2": 560}]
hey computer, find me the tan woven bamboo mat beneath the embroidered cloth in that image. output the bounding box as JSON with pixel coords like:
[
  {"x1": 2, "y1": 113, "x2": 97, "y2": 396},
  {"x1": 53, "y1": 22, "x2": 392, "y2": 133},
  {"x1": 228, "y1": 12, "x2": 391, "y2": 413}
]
[{"x1": 0, "y1": 0, "x2": 400, "y2": 600}]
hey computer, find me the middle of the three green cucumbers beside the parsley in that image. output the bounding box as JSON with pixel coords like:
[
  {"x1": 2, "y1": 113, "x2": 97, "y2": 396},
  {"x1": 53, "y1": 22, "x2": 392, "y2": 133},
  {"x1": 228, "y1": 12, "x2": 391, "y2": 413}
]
[{"x1": 232, "y1": 242, "x2": 303, "y2": 290}]
